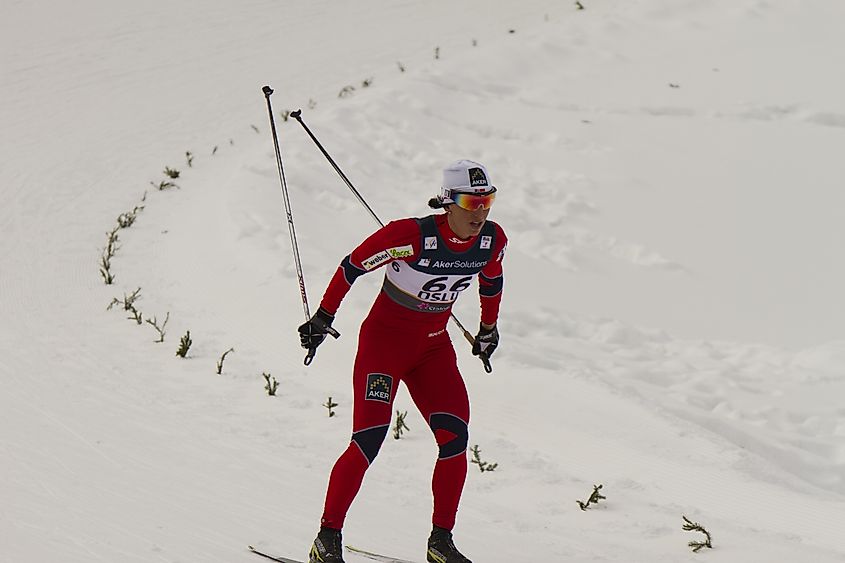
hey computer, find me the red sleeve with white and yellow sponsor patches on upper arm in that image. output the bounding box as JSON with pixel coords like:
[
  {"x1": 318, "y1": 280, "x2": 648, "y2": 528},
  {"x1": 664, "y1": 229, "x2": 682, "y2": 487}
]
[{"x1": 320, "y1": 219, "x2": 420, "y2": 315}]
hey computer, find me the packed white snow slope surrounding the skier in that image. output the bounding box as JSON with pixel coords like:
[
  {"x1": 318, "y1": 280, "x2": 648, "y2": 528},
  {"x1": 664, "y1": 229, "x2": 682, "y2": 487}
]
[{"x1": 0, "y1": 0, "x2": 845, "y2": 563}]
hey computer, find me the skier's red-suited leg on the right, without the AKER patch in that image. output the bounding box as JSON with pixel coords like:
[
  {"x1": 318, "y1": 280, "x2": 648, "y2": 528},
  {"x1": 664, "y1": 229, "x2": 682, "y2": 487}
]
[{"x1": 404, "y1": 334, "x2": 469, "y2": 530}]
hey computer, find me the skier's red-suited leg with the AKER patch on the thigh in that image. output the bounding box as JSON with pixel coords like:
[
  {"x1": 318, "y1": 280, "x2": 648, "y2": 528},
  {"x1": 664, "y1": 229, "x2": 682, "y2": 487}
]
[{"x1": 321, "y1": 327, "x2": 400, "y2": 530}]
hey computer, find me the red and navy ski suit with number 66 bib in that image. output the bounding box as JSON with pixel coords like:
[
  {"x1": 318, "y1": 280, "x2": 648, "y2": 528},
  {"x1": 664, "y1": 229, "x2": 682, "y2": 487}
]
[{"x1": 321, "y1": 215, "x2": 507, "y2": 530}]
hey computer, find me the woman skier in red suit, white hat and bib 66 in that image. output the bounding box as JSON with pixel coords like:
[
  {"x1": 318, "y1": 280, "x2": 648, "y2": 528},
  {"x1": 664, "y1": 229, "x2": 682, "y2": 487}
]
[{"x1": 299, "y1": 160, "x2": 507, "y2": 563}]
